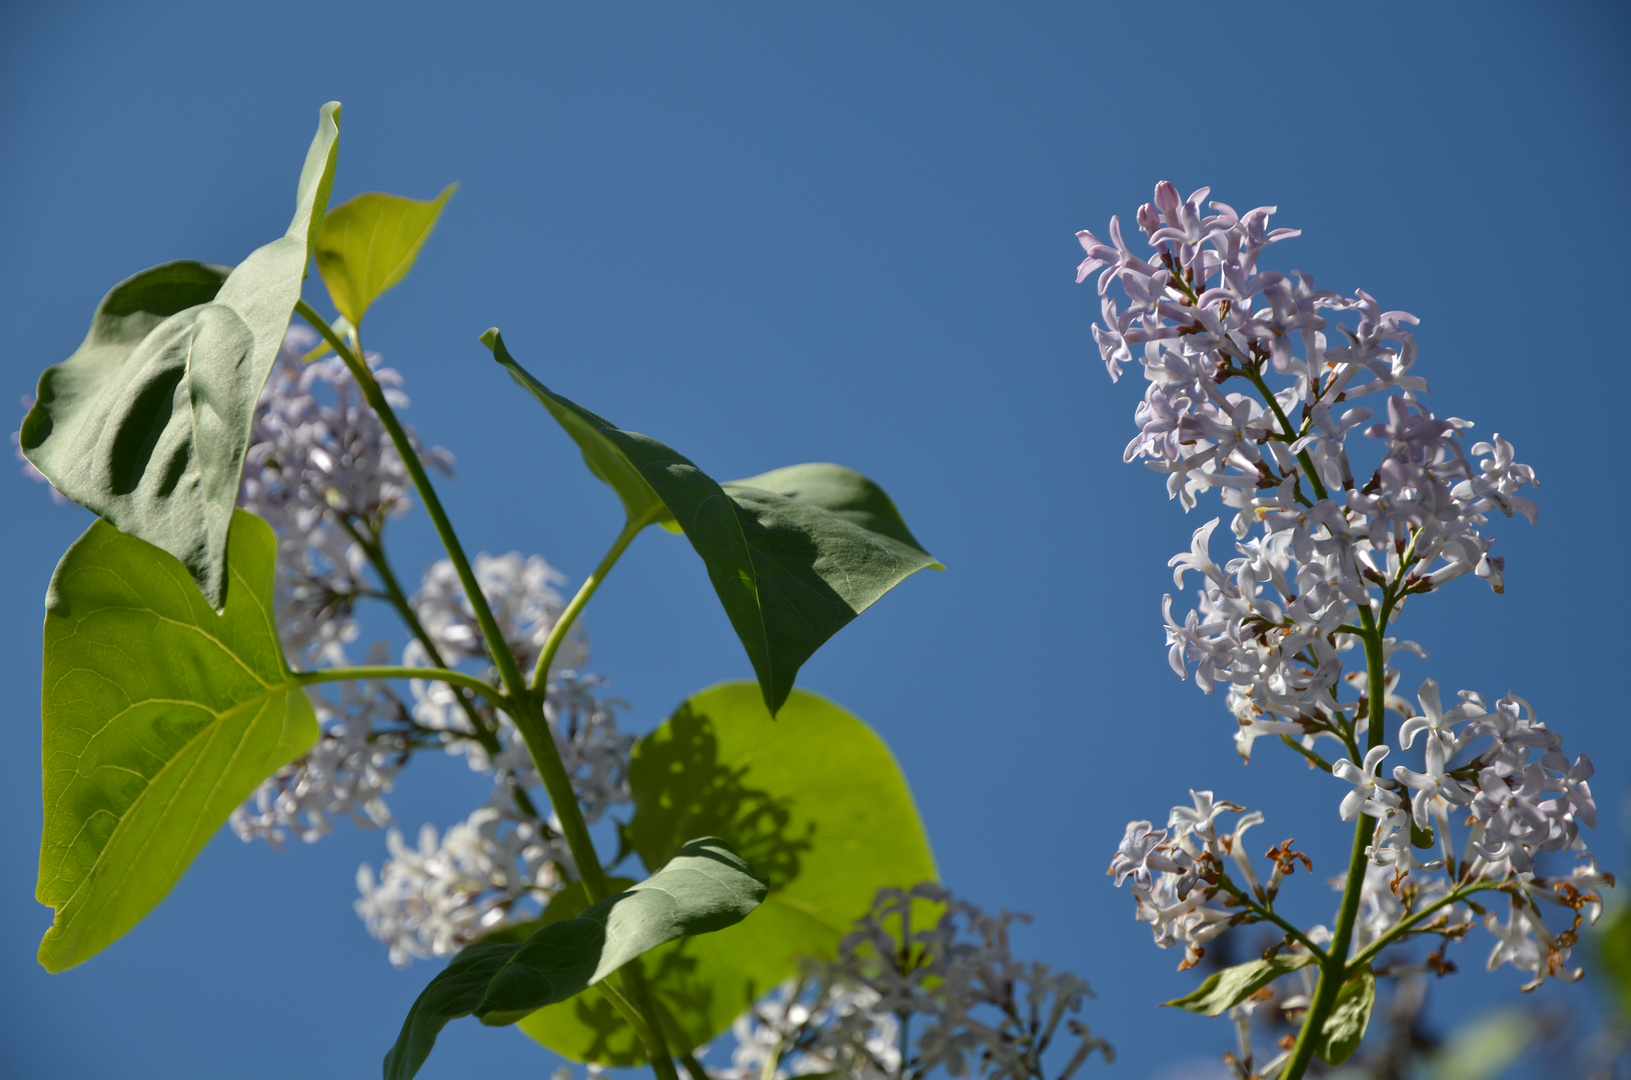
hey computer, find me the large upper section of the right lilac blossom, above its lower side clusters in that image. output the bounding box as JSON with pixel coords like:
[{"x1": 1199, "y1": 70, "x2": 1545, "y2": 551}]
[{"x1": 1076, "y1": 183, "x2": 1535, "y2": 754}]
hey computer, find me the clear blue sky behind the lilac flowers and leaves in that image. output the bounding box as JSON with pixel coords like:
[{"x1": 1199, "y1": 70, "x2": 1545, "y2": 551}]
[{"x1": 0, "y1": 0, "x2": 1631, "y2": 1080}]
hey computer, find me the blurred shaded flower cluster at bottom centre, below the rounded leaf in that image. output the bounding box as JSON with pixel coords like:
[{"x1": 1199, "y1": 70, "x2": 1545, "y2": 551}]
[{"x1": 711, "y1": 883, "x2": 1112, "y2": 1080}]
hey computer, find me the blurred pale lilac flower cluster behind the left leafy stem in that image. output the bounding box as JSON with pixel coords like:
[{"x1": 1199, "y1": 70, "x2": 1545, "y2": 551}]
[{"x1": 232, "y1": 326, "x2": 633, "y2": 966}]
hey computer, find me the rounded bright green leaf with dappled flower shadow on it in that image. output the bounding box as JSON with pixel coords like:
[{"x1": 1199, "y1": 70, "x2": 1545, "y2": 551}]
[{"x1": 520, "y1": 682, "x2": 936, "y2": 1065}]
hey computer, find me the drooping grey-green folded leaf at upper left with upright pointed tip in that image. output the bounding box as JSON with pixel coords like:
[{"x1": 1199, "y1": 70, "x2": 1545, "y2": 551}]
[{"x1": 21, "y1": 101, "x2": 339, "y2": 610}]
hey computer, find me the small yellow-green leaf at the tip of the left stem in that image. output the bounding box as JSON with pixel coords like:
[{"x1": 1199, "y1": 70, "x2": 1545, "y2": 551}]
[{"x1": 313, "y1": 184, "x2": 458, "y2": 326}]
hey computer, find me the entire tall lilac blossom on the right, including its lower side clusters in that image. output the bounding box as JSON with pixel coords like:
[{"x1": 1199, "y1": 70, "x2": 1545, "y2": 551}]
[{"x1": 1076, "y1": 183, "x2": 1613, "y2": 1024}]
